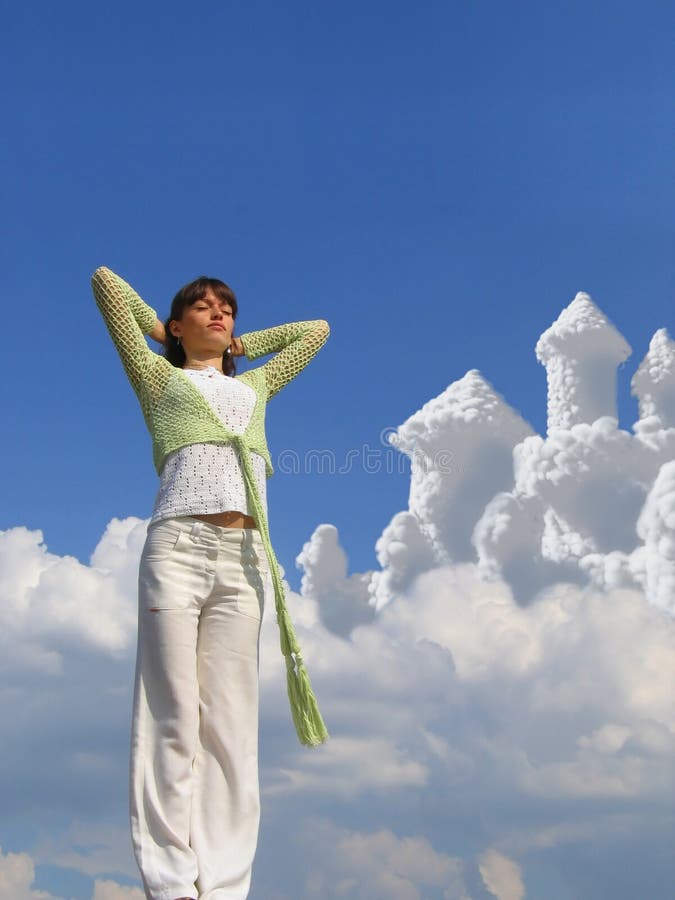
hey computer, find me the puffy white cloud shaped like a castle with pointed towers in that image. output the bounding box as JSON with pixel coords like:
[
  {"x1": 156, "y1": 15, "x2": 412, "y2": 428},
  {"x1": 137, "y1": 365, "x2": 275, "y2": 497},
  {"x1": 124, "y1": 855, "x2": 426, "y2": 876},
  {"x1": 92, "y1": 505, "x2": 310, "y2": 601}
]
[{"x1": 370, "y1": 293, "x2": 675, "y2": 610}]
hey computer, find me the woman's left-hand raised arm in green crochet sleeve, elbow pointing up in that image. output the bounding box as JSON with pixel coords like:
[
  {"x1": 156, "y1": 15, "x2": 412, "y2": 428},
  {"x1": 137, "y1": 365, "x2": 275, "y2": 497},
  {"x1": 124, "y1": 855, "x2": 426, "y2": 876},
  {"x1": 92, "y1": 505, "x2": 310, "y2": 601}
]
[{"x1": 91, "y1": 266, "x2": 157, "y2": 391}]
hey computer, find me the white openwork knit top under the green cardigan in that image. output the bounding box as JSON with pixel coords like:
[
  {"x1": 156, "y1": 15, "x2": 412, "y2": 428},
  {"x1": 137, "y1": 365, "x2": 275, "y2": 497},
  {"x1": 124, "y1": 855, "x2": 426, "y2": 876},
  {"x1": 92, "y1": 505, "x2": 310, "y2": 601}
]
[{"x1": 150, "y1": 366, "x2": 267, "y2": 522}]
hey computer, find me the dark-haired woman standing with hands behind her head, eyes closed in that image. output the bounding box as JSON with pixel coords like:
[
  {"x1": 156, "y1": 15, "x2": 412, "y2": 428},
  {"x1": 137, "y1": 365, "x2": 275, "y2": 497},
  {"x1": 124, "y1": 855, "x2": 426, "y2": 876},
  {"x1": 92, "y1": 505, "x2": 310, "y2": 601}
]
[{"x1": 92, "y1": 267, "x2": 329, "y2": 900}]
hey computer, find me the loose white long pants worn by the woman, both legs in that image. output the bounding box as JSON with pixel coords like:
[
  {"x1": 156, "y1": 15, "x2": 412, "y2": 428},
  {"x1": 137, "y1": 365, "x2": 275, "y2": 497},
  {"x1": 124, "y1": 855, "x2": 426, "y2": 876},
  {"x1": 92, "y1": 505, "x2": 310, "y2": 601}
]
[{"x1": 130, "y1": 516, "x2": 268, "y2": 900}]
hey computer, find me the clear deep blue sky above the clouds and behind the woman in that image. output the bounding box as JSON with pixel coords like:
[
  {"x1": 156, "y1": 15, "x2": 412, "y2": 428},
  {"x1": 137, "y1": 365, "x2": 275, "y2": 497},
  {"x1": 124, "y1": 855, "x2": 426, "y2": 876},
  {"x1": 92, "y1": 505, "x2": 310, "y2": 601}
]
[{"x1": 0, "y1": 0, "x2": 675, "y2": 898}]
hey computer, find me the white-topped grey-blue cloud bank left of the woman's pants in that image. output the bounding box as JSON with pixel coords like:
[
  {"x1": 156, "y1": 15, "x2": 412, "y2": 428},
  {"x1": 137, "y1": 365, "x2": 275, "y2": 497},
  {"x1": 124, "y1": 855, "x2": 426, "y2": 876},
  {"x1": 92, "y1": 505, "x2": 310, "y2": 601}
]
[{"x1": 0, "y1": 519, "x2": 145, "y2": 844}]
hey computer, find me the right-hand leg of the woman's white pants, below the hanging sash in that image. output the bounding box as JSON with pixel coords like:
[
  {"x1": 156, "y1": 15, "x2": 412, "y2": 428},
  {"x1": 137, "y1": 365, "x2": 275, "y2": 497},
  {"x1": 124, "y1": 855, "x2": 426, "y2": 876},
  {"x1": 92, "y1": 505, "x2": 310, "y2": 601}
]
[{"x1": 190, "y1": 529, "x2": 264, "y2": 900}]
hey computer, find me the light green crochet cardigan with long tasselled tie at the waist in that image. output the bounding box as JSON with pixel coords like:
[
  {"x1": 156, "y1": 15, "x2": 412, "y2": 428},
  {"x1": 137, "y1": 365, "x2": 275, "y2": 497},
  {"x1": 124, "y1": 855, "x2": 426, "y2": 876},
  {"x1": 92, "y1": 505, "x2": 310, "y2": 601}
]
[{"x1": 91, "y1": 266, "x2": 330, "y2": 746}]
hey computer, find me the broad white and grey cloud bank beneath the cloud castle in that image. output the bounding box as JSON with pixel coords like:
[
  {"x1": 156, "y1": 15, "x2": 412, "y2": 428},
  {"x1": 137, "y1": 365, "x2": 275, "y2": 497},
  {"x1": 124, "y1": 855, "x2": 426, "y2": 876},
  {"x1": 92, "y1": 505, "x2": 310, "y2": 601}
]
[{"x1": 252, "y1": 564, "x2": 675, "y2": 898}]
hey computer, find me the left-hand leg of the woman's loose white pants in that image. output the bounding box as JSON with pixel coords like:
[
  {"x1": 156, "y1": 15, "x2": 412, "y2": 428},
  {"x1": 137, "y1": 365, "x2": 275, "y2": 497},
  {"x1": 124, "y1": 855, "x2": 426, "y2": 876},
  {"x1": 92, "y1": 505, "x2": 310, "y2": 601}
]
[{"x1": 130, "y1": 519, "x2": 213, "y2": 900}]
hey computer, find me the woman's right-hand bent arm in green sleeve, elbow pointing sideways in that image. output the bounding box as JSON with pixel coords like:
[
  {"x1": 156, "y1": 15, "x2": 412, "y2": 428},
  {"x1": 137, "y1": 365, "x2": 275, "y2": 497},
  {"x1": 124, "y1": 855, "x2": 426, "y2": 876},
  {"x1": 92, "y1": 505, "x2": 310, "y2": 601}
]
[{"x1": 239, "y1": 319, "x2": 330, "y2": 398}]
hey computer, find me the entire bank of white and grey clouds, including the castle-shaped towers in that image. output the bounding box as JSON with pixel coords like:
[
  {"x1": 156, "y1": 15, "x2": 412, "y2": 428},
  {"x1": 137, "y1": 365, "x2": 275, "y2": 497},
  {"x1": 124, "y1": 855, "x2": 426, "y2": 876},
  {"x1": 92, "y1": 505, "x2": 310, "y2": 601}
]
[{"x1": 0, "y1": 295, "x2": 675, "y2": 900}]
